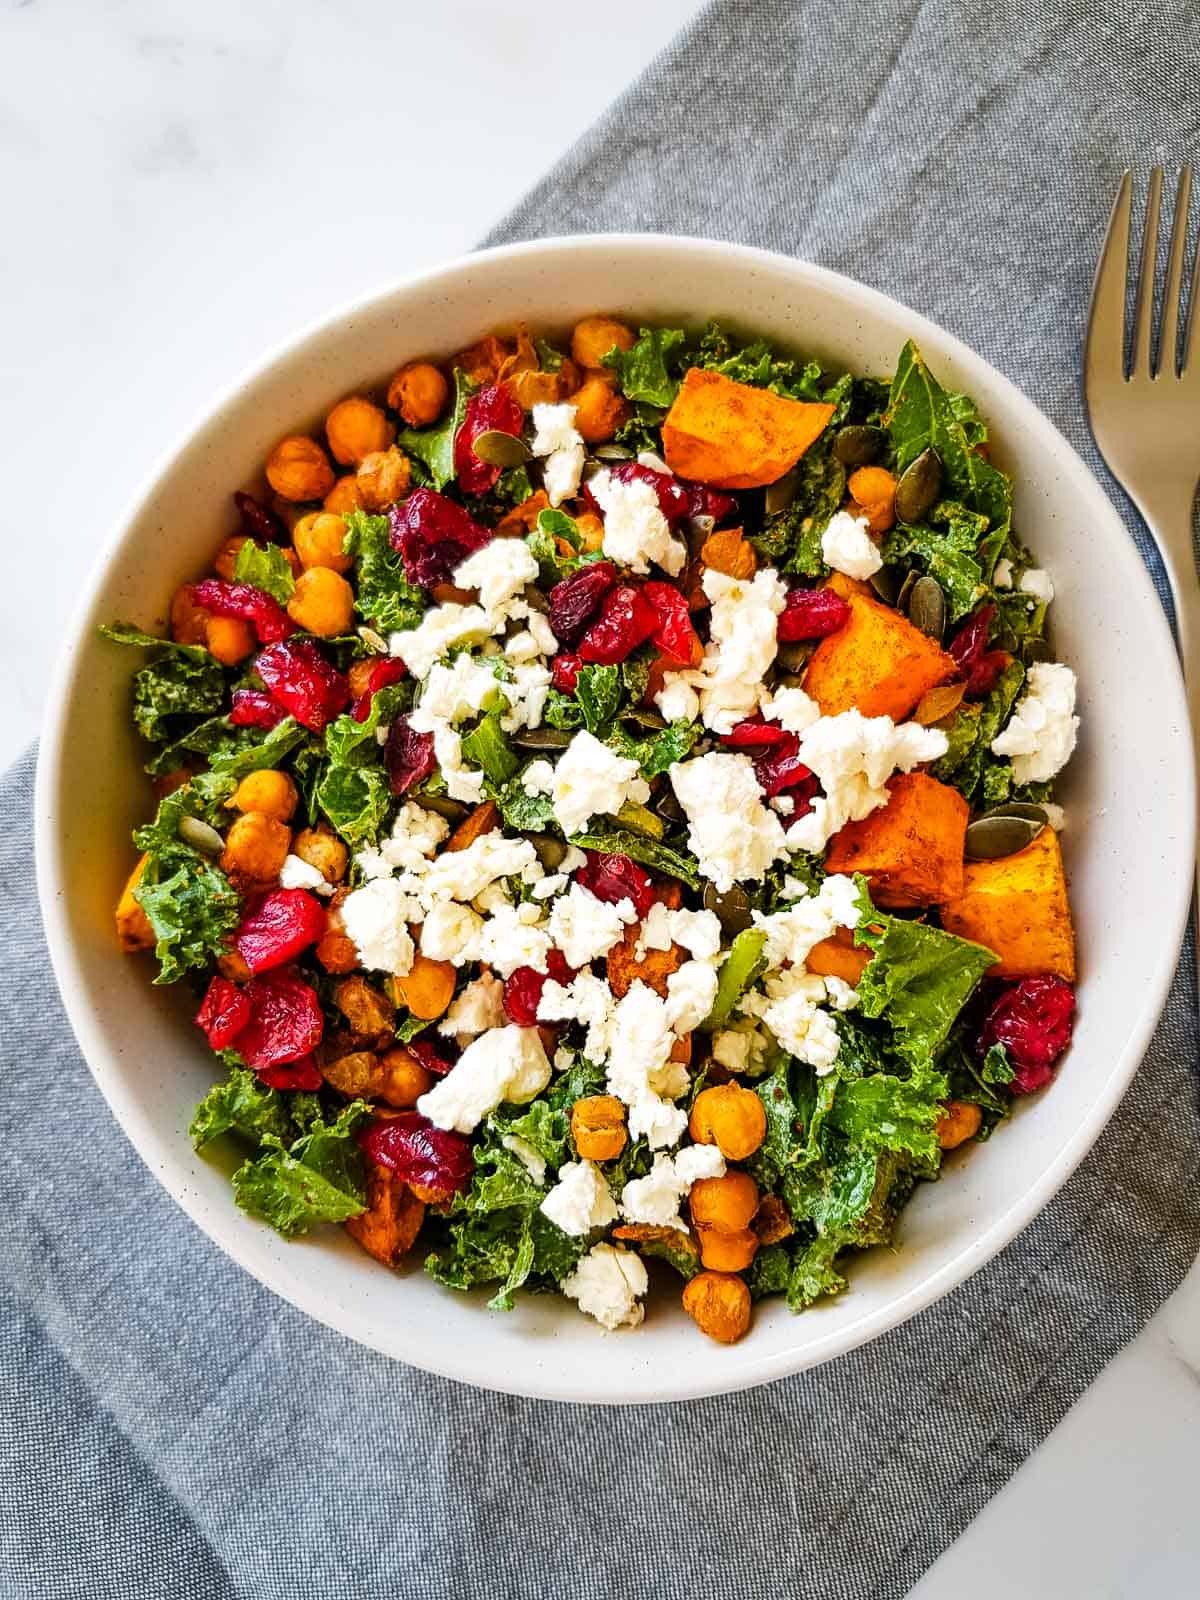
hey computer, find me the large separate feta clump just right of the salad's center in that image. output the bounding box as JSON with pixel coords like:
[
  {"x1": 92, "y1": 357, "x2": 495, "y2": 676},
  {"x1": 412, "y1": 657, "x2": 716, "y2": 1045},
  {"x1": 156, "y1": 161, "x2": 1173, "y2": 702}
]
[{"x1": 669, "y1": 750, "x2": 787, "y2": 893}]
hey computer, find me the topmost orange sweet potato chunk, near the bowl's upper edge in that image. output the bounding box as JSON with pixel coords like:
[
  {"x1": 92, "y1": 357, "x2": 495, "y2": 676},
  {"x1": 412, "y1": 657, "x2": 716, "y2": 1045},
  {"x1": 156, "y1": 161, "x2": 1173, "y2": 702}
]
[{"x1": 662, "y1": 366, "x2": 834, "y2": 490}]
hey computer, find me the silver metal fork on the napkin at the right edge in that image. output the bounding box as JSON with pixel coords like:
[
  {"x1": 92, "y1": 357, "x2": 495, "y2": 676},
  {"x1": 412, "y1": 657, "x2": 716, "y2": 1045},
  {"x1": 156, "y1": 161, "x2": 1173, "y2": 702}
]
[{"x1": 1083, "y1": 166, "x2": 1200, "y2": 965}]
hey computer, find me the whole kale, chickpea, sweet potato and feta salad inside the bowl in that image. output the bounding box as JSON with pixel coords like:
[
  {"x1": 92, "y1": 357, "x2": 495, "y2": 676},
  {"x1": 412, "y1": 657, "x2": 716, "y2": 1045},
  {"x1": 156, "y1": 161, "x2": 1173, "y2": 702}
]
[{"x1": 106, "y1": 305, "x2": 1078, "y2": 1342}]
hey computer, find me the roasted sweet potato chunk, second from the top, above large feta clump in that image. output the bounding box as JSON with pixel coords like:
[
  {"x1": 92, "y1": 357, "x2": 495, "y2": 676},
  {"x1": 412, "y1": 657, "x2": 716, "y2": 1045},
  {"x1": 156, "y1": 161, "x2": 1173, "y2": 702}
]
[{"x1": 805, "y1": 594, "x2": 958, "y2": 722}]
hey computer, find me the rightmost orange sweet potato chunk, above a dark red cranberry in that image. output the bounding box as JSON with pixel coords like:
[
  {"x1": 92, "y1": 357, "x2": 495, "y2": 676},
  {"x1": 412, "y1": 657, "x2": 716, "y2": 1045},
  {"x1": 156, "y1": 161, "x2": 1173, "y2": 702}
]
[{"x1": 941, "y1": 827, "x2": 1075, "y2": 982}]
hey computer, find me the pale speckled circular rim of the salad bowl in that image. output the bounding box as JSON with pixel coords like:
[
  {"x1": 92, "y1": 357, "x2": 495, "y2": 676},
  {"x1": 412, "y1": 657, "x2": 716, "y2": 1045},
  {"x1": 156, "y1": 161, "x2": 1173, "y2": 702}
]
[{"x1": 34, "y1": 232, "x2": 1195, "y2": 1405}]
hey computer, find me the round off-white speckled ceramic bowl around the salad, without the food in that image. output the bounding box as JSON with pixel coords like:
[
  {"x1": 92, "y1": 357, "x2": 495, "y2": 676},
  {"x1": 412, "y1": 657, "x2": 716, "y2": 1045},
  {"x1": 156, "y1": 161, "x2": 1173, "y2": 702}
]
[{"x1": 37, "y1": 235, "x2": 1195, "y2": 1403}]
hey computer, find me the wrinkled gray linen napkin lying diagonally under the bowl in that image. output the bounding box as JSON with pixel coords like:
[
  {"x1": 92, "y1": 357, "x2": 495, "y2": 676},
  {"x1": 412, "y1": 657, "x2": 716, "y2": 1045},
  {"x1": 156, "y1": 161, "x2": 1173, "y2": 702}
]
[{"x1": 0, "y1": 0, "x2": 1200, "y2": 1600}]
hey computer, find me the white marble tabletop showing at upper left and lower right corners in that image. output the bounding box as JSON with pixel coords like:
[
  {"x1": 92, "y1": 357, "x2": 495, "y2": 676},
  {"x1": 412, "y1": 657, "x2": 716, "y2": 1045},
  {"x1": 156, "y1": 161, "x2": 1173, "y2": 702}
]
[{"x1": 0, "y1": 0, "x2": 1200, "y2": 1600}]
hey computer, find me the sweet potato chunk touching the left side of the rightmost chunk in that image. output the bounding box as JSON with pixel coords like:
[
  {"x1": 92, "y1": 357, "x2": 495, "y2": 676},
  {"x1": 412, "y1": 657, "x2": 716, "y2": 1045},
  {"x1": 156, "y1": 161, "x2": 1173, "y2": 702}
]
[{"x1": 826, "y1": 773, "x2": 970, "y2": 907}]
